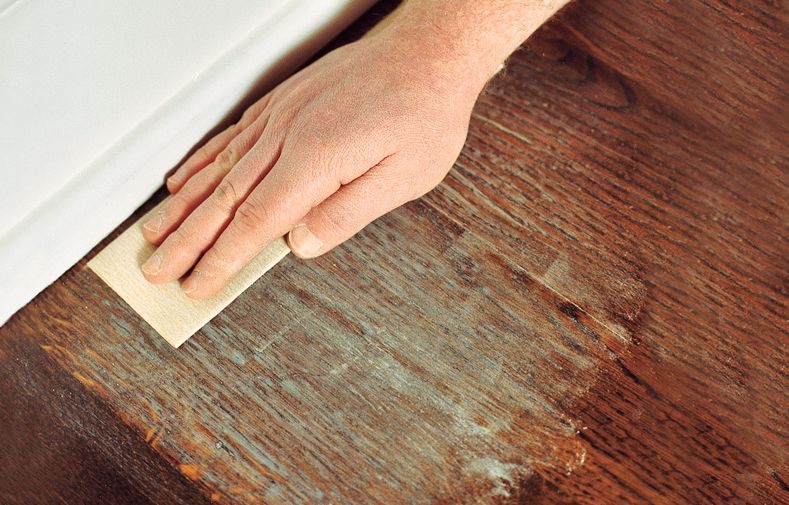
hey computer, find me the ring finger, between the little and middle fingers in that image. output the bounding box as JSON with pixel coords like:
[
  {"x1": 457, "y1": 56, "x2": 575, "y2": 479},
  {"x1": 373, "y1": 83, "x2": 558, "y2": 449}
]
[{"x1": 142, "y1": 117, "x2": 268, "y2": 245}]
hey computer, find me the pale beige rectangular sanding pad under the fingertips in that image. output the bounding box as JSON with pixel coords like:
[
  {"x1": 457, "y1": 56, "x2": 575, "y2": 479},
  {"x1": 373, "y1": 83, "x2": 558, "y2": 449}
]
[{"x1": 88, "y1": 202, "x2": 290, "y2": 347}]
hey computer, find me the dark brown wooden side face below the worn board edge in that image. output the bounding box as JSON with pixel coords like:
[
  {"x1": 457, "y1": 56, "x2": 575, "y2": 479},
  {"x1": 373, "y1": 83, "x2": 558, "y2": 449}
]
[{"x1": 0, "y1": 328, "x2": 211, "y2": 505}]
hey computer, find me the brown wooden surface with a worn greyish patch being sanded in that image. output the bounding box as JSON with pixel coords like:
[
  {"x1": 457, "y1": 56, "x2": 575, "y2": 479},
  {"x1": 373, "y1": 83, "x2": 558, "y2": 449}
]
[{"x1": 0, "y1": 0, "x2": 789, "y2": 505}]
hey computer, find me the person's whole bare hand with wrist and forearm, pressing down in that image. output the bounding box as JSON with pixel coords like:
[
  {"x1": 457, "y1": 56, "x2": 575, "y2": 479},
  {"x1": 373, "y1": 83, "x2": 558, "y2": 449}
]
[{"x1": 142, "y1": 0, "x2": 565, "y2": 298}]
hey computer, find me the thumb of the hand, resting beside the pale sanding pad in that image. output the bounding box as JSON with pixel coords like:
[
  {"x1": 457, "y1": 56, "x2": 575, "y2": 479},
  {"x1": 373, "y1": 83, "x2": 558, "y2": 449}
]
[{"x1": 287, "y1": 160, "x2": 412, "y2": 258}]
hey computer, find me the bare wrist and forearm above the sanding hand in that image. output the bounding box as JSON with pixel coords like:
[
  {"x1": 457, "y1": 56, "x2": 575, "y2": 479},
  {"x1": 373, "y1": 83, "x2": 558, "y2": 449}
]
[{"x1": 372, "y1": 0, "x2": 569, "y2": 92}]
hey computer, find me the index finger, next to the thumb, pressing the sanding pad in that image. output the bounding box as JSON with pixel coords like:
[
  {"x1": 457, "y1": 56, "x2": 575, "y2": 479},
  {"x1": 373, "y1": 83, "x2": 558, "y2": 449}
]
[{"x1": 182, "y1": 152, "x2": 346, "y2": 298}]
